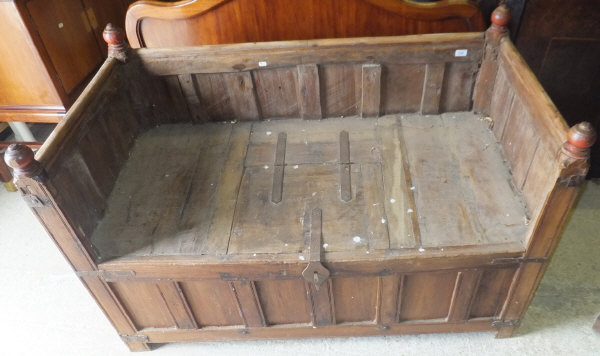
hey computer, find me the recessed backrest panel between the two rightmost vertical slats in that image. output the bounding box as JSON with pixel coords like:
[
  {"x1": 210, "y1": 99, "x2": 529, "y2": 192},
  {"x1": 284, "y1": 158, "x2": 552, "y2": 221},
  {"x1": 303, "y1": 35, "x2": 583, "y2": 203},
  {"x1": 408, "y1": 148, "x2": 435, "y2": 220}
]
[{"x1": 381, "y1": 61, "x2": 429, "y2": 114}]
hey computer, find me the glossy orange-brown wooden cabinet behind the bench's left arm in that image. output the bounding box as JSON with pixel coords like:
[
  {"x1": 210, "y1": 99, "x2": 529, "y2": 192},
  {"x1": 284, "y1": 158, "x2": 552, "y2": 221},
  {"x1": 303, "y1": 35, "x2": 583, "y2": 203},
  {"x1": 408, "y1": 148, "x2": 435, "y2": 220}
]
[{"x1": 0, "y1": 0, "x2": 128, "y2": 122}]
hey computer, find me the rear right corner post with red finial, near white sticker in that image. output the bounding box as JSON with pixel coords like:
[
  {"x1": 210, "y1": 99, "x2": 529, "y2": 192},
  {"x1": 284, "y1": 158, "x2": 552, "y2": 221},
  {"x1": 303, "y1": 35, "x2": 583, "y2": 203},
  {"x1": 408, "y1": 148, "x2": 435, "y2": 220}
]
[{"x1": 473, "y1": 4, "x2": 510, "y2": 115}]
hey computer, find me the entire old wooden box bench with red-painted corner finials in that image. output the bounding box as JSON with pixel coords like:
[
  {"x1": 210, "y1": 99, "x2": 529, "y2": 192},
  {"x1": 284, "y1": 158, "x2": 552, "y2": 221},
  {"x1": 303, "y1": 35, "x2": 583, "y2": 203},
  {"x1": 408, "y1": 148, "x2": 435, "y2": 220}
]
[{"x1": 7, "y1": 4, "x2": 594, "y2": 350}]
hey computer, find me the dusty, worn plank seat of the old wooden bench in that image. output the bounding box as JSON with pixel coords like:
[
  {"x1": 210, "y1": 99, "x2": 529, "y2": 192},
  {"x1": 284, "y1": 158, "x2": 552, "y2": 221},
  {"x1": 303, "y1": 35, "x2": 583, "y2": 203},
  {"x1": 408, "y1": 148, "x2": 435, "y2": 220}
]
[{"x1": 92, "y1": 113, "x2": 527, "y2": 260}]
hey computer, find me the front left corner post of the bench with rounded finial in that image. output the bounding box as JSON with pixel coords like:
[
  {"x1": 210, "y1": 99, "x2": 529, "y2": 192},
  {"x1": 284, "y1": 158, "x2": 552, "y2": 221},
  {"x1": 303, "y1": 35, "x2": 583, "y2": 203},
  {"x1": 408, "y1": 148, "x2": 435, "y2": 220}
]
[{"x1": 4, "y1": 144, "x2": 149, "y2": 351}]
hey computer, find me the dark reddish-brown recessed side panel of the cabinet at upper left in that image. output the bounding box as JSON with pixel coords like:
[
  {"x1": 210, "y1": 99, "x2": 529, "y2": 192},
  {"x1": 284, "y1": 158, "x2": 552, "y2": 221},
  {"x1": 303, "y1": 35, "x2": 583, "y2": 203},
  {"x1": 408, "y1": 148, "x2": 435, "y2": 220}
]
[{"x1": 27, "y1": 0, "x2": 103, "y2": 93}]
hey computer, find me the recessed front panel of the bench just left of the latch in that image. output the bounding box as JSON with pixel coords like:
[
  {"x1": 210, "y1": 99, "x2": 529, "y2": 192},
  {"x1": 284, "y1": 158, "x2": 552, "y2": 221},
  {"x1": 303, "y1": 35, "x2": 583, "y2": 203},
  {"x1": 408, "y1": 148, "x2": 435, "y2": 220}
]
[{"x1": 255, "y1": 279, "x2": 311, "y2": 325}]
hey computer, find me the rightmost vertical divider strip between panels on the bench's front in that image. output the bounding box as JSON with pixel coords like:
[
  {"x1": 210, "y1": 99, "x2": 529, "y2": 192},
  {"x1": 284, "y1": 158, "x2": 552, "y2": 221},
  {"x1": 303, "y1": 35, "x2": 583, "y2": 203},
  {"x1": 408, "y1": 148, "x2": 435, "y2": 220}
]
[{"x1": 448, "y1": 270, "x2": 482, "y2": 322}]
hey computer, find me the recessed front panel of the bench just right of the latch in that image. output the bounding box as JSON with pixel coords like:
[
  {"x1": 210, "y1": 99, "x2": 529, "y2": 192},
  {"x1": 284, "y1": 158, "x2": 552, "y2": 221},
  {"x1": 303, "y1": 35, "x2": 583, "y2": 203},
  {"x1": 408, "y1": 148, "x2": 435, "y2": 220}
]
[{"x1": 332, "y1": 277, "x2": 379, "y2": 323}]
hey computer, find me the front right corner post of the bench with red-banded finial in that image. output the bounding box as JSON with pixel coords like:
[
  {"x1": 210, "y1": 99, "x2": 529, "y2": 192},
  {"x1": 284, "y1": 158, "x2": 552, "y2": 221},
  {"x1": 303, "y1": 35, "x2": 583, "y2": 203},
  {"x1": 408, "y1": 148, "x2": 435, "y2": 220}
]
[{"x1": 496, "y1": 122, "x2": 597, "y2": 338}]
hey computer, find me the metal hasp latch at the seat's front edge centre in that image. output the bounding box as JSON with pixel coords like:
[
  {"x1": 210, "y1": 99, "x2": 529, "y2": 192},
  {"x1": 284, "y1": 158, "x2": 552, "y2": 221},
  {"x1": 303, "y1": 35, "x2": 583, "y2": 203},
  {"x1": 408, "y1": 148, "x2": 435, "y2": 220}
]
[{"x1": 302, "y1": 208, "x2": 330, "y2": 290}]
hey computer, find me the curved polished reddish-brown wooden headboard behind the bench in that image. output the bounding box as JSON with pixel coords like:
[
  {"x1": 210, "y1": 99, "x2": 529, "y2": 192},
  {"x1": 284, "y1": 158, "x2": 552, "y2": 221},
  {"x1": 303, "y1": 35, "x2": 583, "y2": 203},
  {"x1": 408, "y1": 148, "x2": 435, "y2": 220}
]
[{"x1": 126, "y1": 0, "x2": 485, "y2": 48}]
